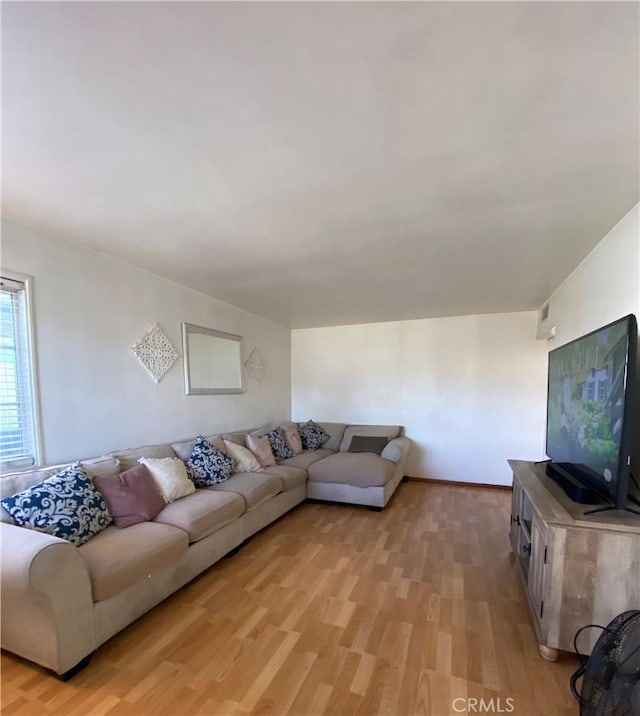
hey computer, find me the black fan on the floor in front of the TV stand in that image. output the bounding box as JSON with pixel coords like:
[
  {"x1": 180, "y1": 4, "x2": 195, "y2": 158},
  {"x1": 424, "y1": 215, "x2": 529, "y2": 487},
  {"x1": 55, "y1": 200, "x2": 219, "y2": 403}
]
[{"x1": 571, "y1": 609, "x2": 640, "y2": 716}]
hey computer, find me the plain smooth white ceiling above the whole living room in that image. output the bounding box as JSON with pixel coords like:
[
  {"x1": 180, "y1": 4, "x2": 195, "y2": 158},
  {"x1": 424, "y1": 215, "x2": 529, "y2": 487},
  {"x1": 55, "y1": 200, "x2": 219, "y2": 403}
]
[{"x1": 2, "y1": 2, "x2": 640, "y2": 327}]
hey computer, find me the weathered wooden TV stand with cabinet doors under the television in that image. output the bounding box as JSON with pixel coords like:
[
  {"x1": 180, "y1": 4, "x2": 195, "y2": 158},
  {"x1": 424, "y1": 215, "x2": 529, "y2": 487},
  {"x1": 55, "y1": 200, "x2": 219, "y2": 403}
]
[{"x1": 509, "y1": 460, "x2": 640, "y2": 661}]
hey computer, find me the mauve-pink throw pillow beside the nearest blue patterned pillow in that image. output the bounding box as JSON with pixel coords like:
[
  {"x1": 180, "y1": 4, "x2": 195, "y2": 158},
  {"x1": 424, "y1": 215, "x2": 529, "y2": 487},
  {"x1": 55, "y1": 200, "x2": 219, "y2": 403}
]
[{"x1": 93, "y1": 465, "x2": 166, "y2": 528}]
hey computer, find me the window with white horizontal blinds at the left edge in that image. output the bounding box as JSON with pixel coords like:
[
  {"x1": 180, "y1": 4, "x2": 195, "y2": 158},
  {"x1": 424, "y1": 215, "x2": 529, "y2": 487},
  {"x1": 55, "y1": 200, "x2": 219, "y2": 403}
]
[{"x1": 0, "y1": 271, "x2": 40, "y2": 472}]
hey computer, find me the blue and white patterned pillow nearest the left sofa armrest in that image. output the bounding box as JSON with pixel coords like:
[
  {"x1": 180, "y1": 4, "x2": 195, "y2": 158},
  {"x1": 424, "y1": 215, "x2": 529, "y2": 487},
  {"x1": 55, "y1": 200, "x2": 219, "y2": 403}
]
[{"x1": 0, "y1": 462, "x2": 112, "y2": 547}]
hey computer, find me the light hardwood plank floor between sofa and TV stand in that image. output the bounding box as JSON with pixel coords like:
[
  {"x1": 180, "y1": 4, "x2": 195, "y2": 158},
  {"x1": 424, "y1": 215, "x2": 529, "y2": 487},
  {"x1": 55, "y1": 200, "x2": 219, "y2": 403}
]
[{"x1": 1, "y1": 482, "x2": 578, "y2": 716}]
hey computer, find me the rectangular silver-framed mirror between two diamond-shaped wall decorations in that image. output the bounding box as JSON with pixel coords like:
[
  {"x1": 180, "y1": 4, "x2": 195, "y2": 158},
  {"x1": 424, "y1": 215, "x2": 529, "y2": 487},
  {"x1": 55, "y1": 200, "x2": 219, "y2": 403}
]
[{"x1": 182, "y1": 323, "x2": 244, "y2": 395}]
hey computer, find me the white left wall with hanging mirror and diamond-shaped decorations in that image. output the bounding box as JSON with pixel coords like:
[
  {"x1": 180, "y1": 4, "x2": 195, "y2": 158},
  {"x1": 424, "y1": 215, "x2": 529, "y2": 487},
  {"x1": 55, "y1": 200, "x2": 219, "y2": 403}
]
[{"x1": 2, "y1": 220, "x2": 291, "y2": 464}]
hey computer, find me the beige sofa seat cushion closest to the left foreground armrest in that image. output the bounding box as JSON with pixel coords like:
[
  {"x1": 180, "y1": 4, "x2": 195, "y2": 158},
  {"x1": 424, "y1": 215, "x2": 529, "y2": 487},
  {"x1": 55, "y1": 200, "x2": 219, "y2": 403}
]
[{"x1": 78, "y1": 522, "x2": 189, "y2": 602}]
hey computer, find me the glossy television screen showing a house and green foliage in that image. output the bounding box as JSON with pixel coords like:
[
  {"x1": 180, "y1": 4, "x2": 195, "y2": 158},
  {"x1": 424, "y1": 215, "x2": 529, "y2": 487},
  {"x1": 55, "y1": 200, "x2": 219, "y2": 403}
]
[{"x1": 547, "y1": 316, "x2": 635, "y2": 501}]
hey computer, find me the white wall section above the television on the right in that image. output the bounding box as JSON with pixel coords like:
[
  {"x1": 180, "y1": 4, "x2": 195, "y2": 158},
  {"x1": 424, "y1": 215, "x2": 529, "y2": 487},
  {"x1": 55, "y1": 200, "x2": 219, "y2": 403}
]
[{"x1": 547, "y1": 204, "x2": 640, "y2": 348}]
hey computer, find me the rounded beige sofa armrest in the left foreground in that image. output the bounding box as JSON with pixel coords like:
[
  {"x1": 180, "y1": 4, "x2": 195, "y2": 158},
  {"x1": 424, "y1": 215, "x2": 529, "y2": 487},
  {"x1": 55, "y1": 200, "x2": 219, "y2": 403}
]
[{"x1": 0, "y1": 522, "x2": 95, "y2": 674}]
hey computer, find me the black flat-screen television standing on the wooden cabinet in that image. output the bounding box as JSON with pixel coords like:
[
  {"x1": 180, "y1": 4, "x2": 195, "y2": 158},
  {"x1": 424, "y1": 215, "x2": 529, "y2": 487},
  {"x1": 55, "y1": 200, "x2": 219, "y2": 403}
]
[{"x1": 546, "y1": 315, "x2": 640, "y2": 514}]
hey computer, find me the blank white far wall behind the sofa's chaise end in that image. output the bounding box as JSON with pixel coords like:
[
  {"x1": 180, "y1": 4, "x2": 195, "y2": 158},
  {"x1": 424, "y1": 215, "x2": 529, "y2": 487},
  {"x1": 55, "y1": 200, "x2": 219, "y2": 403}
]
[{"x1": 291, "y1": 312, "x2": 547, "y2": 485}]
